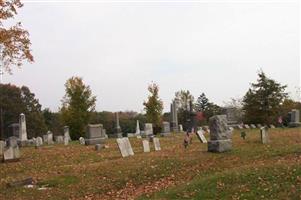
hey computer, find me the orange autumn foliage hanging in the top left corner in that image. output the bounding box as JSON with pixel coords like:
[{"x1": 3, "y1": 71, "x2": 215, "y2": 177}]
[{"x1": 0, "y1": 0, "x2": 33, "y2": 72}]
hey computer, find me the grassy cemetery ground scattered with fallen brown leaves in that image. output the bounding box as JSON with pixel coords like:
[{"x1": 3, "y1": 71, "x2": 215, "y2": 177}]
[{"x1": 0, "y1": 128, "x2": 301, "y2": 199}]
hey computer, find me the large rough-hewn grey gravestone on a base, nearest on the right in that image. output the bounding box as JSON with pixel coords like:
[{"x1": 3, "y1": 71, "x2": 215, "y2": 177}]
[{"x1": 208, "y1": 115, "x2": 232, "y2": 152}]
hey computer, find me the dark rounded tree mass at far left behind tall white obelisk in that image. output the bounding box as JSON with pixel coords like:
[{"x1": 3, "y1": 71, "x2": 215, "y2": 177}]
[{"x1": 0, "y1": 84, "x2": 46, "y2": 138}]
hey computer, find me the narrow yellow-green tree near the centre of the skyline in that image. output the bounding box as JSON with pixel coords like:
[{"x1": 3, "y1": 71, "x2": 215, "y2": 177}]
[{"x1": 143, "y1": 83, "x2": 163, "y2": 133}]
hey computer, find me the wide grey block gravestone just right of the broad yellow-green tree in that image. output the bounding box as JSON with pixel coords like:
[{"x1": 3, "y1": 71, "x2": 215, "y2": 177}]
[{"x1": 85, "y1": 124, "x2": 106, "y2": 145}]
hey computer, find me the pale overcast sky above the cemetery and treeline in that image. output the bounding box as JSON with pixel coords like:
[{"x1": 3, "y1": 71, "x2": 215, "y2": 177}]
[{"x1": 3, "y1": 0, "x2": 300, "y2": 112}]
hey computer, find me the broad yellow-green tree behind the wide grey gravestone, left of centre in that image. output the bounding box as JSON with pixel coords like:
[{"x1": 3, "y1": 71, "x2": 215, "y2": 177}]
[{"x1": 60, "y1": 77, "x2": 96, "y2": 139}]
